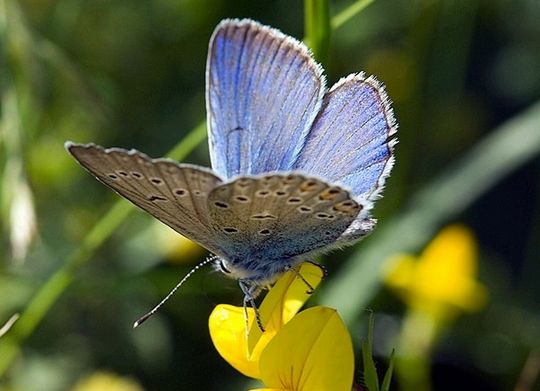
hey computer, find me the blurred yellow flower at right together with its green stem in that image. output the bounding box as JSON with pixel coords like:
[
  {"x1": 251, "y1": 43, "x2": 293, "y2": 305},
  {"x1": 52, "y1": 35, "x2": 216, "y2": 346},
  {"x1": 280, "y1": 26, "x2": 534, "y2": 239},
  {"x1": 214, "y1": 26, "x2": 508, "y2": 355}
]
[{"x1": 386, "y1": 225, "x2": 487, "y2": 391}]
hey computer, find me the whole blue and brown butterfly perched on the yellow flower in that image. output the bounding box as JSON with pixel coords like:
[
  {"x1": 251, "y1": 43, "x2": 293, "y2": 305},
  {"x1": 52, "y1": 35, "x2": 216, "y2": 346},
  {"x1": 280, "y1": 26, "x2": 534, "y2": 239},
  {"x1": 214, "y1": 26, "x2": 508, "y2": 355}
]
[{"x1": 66, "y1": 19, "x2": 397, "y2": 328}]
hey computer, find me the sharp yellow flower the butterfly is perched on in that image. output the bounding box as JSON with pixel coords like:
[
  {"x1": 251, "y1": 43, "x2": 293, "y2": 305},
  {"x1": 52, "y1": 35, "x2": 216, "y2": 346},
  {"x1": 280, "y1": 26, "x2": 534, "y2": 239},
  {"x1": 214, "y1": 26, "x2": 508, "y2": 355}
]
[{"x1": 209, "y1": 263, "x2": 354, "y2": 391}]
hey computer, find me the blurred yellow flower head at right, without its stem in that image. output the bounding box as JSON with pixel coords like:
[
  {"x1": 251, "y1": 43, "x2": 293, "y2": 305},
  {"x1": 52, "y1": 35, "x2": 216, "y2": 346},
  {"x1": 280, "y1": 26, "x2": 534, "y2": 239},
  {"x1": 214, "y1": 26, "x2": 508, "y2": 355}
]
[{"x1": 386, "y1": 225, "x2": 487, "y2": 319}]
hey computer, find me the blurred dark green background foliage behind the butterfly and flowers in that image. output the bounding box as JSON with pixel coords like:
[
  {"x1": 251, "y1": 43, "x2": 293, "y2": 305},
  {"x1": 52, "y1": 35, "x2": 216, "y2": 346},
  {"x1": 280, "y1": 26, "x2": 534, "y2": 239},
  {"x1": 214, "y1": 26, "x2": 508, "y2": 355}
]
[{"x1": 0, "y1": 0, "x2": 540, "y2": 391}]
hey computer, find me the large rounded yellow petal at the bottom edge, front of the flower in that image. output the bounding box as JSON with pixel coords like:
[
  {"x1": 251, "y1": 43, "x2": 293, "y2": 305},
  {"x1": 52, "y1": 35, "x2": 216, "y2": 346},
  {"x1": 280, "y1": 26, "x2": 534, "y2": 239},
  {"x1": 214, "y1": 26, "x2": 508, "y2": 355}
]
[{"x1": 259, "y1": 307, "x2": 354, "y2": 391}]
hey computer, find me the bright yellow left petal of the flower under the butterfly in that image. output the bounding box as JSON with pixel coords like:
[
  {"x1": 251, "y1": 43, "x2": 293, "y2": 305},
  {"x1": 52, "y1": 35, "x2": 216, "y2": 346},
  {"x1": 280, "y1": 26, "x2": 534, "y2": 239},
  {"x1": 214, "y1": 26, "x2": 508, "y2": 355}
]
[{"x1": 208, "y1": 304, "x2": 260, "y2": 378}]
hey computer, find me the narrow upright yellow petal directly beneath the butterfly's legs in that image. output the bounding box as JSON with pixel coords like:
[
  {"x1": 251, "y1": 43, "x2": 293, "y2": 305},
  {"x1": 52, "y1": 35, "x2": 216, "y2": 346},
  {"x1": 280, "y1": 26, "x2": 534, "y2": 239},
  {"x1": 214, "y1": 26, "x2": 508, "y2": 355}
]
[{"x1": 248, "y1": 262, "x2": 323, "y2": 355}]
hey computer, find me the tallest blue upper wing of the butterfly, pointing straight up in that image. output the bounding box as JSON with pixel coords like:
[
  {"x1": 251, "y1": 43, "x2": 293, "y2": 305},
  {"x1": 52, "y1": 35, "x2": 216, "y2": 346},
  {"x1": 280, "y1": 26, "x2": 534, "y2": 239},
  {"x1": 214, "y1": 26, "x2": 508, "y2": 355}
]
[{"x1": 206, "y1": 20, "x2": 324, "y2": 178}]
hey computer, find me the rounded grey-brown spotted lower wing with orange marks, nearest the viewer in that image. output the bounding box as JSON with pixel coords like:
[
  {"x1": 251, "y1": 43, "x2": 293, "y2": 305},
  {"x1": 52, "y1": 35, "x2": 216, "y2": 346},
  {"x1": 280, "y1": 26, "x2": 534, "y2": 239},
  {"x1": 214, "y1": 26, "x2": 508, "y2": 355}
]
[{"x1": 208, "y1": 174, "x2": 362, "y2": 280}]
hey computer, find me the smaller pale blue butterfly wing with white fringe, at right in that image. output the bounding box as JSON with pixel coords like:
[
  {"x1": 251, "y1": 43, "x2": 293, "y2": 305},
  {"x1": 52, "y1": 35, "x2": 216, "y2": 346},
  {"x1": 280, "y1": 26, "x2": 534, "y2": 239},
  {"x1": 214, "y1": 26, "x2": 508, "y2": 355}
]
[{"x1": 294, "y1": 73, "x2": 397, "y2": 208}]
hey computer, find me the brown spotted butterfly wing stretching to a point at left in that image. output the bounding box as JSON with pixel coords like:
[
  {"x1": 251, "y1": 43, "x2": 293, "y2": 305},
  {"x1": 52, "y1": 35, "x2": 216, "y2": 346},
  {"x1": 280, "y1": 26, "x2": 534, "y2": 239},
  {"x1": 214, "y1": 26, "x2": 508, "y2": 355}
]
[{"x1": 66, "y1": 143, "x2": 225, "y2": 254}]
